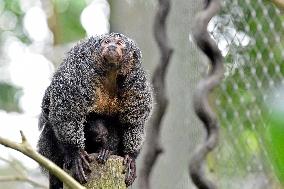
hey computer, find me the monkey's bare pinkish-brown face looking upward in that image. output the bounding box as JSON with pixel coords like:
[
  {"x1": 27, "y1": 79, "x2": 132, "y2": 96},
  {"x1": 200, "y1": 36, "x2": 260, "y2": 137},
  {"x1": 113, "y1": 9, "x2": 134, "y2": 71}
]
[{"x1": 101, "y1": 36, "x2": 126, "y2": 68}]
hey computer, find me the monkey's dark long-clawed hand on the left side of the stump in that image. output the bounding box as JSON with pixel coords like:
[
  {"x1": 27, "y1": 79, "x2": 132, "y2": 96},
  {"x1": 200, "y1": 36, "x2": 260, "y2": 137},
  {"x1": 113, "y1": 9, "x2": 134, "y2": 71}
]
[{"x1": 65, "y1": 149, "x2": 93, "y2": 184}]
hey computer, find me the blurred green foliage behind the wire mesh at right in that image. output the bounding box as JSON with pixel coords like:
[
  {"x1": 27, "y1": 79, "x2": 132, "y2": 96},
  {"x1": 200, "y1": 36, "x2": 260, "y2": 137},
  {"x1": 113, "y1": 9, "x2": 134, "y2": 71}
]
[{"x1": 211, "y1": 0, "x2": 284, "y2": 186}]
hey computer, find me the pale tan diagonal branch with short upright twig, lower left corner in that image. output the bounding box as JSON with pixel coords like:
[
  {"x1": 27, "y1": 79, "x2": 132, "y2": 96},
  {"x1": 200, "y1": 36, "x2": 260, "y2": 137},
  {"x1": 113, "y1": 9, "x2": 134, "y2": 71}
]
[{"x1": 0, "y1": 131, "x2": 85, "y2": 189}]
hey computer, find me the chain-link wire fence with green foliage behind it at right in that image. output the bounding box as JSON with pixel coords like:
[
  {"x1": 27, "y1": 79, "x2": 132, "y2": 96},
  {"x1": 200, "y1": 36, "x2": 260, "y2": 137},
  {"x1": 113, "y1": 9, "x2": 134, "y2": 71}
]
[{"x1": 208, "y1": 0, "x2": 284, "y2": 189}]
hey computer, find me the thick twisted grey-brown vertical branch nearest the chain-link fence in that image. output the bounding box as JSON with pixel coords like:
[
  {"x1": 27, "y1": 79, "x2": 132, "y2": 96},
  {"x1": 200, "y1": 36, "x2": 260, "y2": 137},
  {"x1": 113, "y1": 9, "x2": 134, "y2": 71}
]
[{"x1": 189, "y1": 0, "x2": 223, "y2": 189}]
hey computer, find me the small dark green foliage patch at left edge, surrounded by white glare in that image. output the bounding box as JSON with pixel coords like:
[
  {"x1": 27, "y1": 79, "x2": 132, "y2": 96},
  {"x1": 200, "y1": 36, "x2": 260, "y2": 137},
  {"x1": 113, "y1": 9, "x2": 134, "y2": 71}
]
[{"x1": 0, "y1": 83, "x2": 21, "y2": 112}]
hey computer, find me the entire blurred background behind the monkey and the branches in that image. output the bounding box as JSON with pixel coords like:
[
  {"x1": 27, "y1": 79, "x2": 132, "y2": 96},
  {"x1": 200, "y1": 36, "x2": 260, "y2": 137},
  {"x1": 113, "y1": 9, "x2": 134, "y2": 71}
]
[{"x1": 0, "y1": 0, "x2": 284, "y2": 189}]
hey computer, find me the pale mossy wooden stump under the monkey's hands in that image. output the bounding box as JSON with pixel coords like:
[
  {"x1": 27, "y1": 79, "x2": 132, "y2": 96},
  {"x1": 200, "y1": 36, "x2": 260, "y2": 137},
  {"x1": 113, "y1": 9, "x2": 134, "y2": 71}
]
[{"x1": 64, "y1": 154, "x2": 127, "y2": 189}]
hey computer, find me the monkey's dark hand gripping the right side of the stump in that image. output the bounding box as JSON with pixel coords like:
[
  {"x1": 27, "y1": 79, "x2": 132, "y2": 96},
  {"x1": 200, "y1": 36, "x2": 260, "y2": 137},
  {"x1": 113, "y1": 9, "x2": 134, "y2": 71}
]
[{"x1": 123, "y1": 155, "x2": 137, "y2": 187}]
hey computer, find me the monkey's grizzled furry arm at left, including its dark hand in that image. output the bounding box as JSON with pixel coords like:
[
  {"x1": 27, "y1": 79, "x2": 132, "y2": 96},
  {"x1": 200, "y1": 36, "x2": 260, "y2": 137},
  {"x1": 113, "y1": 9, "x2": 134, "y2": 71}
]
[{"x1": 49, "y1": 78, "x2": 89, "y2": 183}]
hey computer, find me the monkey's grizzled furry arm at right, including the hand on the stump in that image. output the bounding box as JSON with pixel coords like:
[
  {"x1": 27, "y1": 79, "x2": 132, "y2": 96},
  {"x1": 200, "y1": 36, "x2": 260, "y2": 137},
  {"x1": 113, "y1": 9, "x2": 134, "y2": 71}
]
[{"x1": 120, "y1": 69, "x2": 153, "y2": 186}]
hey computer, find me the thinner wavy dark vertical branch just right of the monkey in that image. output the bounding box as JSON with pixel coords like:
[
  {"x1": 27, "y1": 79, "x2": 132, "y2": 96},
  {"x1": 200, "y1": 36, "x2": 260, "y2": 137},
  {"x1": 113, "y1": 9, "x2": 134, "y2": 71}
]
[{"x1": 139, "y1": 0, "x2": 173, "y2": 189}]
